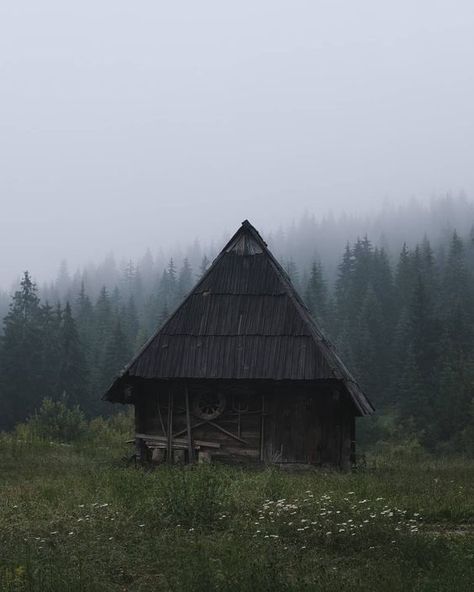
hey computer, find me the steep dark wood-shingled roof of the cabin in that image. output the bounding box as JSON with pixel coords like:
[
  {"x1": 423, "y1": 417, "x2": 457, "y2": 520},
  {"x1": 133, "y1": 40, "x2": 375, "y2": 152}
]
[{"x1": 104, "y1": 220, "x2": 373, "y2": 415}]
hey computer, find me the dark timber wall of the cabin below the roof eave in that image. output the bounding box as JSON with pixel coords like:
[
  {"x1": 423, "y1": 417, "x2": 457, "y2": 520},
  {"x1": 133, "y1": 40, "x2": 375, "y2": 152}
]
[{"x1": 135, "y1": 382, "x2": 354, "y2": 469}]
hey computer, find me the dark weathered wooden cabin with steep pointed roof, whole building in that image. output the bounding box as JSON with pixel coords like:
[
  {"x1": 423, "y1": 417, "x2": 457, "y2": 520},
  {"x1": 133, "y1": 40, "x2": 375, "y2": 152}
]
[{"x1": 104, "y1": 221, "x2": 373, "y2": 469}]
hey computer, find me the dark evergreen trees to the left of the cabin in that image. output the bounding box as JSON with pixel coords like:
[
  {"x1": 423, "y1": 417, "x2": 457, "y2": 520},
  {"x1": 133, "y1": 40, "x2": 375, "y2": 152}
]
[{"x1": 0, "y1": 259, "x2": 198, "y2": 428}]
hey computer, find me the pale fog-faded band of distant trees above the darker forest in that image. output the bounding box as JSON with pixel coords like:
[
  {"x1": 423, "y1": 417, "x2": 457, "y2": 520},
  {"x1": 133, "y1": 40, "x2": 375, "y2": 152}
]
[{"x1": 0, "y1": 195, "x2": 466, "y2": 308}]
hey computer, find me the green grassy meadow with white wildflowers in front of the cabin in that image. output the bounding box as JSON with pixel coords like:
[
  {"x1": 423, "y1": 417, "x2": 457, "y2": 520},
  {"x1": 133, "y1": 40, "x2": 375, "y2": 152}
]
[{"x1": 0, "y1": 436, "x2": 474, "y2": 592}]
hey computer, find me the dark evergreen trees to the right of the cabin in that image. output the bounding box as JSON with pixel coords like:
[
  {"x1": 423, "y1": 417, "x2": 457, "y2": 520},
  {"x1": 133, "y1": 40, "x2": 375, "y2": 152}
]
[{"x1": 304, "y1": 231, "x2": 474, "y2": 452}]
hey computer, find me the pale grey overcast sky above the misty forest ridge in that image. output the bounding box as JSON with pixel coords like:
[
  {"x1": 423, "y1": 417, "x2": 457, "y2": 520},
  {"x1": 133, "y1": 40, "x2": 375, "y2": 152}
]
[{"x1": 0, "y1": 0, "x2": 474, "y2": 285}]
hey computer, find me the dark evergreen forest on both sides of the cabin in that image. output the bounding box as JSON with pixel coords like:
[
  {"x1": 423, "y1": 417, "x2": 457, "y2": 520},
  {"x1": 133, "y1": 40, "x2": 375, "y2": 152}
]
[{"x1": 0, "y1": 232, "x2": 474, "y2": 450}]
